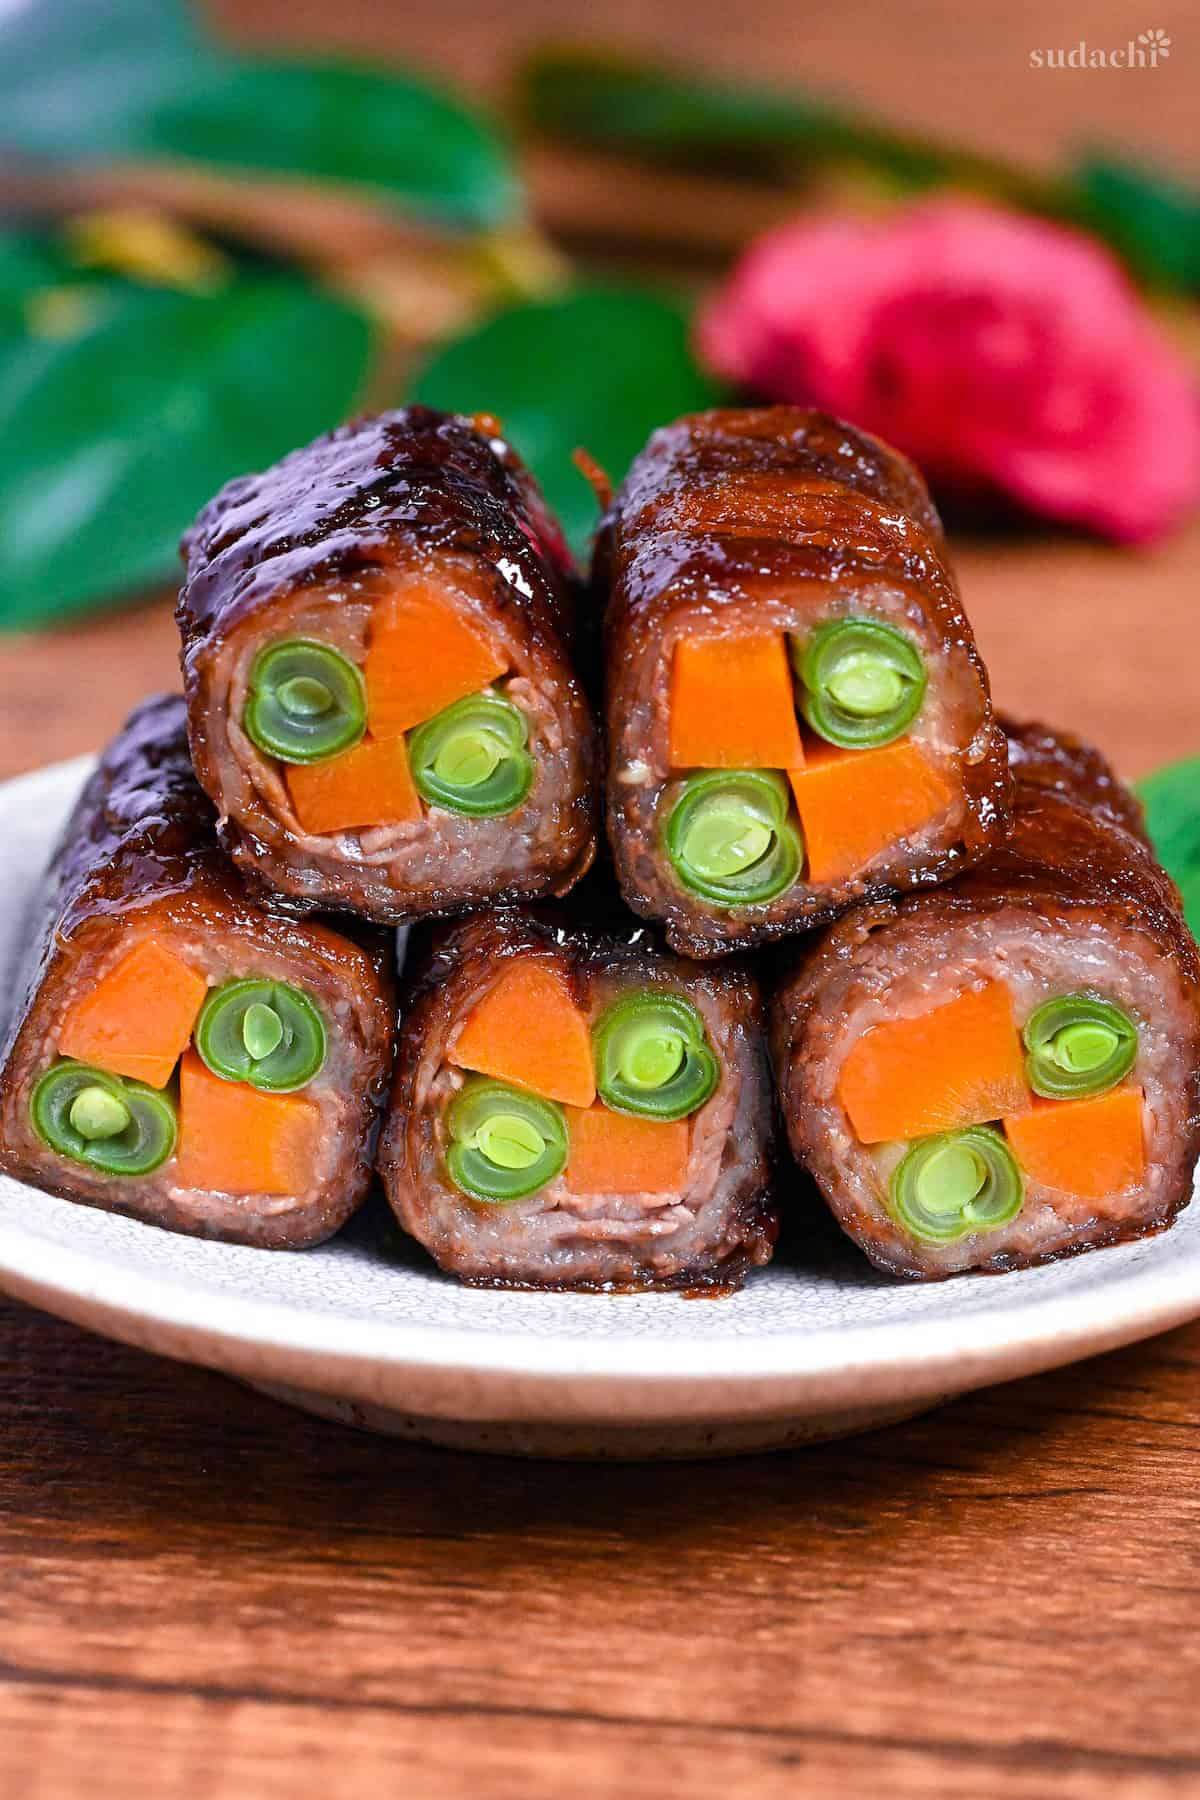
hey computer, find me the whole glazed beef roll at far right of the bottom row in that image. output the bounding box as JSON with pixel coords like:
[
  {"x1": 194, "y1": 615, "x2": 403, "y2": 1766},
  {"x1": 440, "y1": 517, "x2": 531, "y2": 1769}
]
[{"x1": 772, "y1": 727, "x2": 1200, "y2": 1276}]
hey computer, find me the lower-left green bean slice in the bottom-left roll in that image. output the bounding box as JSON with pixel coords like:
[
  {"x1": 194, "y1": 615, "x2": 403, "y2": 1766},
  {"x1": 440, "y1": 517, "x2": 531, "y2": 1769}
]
[{"x1": 29, "y1": 1057, "x2": 178, "y2": 1175}]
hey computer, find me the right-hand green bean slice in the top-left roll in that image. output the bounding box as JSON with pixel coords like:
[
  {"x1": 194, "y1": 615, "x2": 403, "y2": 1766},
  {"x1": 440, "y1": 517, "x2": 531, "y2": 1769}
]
[{"x1": 408, "y1": 688, "x2": 534, "y2": 819}]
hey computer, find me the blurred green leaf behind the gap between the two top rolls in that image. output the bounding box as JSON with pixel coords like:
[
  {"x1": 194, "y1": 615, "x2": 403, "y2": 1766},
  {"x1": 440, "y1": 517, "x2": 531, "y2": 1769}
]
[{"x1": 412, "y1": 286, "x2": 720, "y2": 553}]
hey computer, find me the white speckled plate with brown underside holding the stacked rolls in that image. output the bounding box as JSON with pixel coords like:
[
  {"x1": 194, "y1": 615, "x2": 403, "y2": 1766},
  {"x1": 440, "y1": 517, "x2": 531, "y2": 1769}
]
[{"x1": 0, "y1": 760, "x2": 1200, "y2": 1456}]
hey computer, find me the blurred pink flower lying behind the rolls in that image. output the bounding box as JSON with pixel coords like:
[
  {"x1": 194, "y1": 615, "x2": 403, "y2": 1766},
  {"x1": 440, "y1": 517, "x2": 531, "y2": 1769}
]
[{"x1": 698, "y1": 200, "x2": 1200, "y2": 544}]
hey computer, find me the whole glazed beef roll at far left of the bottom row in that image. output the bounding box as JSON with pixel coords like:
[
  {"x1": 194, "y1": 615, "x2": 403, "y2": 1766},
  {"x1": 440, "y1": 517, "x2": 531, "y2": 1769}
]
[{"x1": 0, "y1": 697, "x2": 394, "y2": 1249}]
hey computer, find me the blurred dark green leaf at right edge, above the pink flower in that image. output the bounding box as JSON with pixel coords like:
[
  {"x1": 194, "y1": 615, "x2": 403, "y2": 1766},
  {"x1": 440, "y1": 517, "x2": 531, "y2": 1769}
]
[{"x1": 1076, "y1": 155, "x2": 1200, "y2": 288}]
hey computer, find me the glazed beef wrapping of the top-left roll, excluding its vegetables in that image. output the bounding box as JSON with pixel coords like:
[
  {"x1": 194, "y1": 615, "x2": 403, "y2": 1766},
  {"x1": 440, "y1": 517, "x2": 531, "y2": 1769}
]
[{"x1": 176, "y1": 407, "x2": 597, "y2": 923}]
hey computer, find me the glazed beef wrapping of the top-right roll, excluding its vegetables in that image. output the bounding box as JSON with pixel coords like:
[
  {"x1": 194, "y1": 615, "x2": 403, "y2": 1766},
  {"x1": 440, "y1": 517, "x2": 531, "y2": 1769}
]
[{"x1": 596, "y1": 407, "x2": 1009, "y2": 958}]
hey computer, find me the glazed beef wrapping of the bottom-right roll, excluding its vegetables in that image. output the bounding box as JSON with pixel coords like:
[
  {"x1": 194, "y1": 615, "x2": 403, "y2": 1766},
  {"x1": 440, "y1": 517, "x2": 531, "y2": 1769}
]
[{"x1": 772, "y1": 722, "x2": 1200, "y2": 1278}]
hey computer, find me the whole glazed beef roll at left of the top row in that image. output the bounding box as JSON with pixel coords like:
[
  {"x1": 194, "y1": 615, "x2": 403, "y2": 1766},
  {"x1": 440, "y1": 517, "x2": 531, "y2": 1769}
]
[{"x1": 178, "y1": 407, "x2": 596, "y2": 923}]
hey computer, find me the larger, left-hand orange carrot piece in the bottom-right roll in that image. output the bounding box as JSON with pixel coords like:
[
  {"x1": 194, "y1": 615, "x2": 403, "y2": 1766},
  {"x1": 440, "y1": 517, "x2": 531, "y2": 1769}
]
[{"x1": 838, "y1": 981, "x2": 1033, "y2": 1143}]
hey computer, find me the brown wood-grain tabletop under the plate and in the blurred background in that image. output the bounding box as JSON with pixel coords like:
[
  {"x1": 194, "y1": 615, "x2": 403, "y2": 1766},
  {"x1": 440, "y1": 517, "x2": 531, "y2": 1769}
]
[{"x1": 0, "y1": 0, "x2": 1200, "y2": 1800}]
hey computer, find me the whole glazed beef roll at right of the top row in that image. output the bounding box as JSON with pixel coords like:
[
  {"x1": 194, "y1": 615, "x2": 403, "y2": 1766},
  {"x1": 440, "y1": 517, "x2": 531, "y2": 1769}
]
[{"x1": 596, "y1": 407, "x2": 1007, "y2": 956}]
